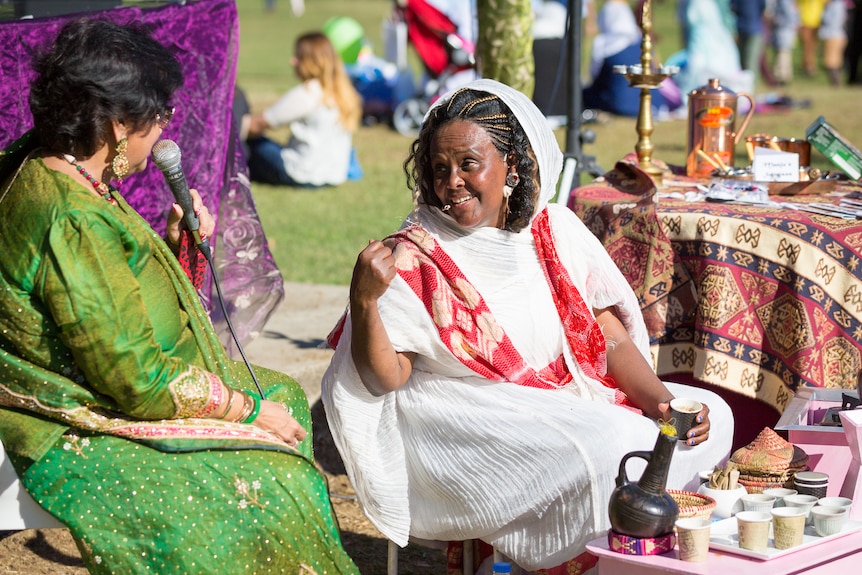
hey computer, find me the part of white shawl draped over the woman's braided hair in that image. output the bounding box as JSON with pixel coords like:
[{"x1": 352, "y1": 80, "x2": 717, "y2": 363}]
[{"x1": 426, "y1": 79, "x2": 563, "y2": 216}]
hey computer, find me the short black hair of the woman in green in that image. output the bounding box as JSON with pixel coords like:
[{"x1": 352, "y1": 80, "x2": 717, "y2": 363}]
[{"x1": 30, "y1": 18, "x2": 183, "y2": 158}]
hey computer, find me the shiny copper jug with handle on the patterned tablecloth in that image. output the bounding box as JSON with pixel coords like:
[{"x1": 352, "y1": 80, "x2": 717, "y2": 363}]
[{"x1": 685, "y1": 78, "x2": 754, "y2": 177}]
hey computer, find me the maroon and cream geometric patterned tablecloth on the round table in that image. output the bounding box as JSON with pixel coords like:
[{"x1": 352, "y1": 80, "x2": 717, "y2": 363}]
[{"x1": 569, "y1": 158, "x2": 862, "y2": 412}]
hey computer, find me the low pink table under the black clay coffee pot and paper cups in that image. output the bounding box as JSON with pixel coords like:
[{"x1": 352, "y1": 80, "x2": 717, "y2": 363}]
[{"x1": 587, "y1": 531, "x2": 862, "y2": 575}]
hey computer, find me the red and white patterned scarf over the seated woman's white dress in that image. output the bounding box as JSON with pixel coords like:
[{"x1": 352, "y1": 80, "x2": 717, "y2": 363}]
[{"x1": 329, "y1": 209, "x2": 628, "y2": 405}]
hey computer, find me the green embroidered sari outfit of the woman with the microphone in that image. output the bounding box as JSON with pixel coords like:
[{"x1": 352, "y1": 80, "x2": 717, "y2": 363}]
[{"x1": 0, "y1": 150, "x2": 357, "y2": 575}]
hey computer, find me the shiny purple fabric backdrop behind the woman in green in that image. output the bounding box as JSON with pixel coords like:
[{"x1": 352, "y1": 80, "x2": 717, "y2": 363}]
[{"x1": 0, "y1": 0, "x2": 284, "y2": 355}]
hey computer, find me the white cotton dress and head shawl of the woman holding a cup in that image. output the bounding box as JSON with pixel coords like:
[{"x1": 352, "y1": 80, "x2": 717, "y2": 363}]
[{"x1": 322, "y1": 80, "x2": 733, "y2": 569}]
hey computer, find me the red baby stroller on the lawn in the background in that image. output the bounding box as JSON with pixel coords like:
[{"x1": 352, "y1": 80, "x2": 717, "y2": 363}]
[{"x1": 392, "y1": 0, "x2": 476, "y2": 136}]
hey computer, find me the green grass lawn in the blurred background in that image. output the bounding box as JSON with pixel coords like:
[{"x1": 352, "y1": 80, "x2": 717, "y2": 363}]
[{"x1": 237, "y1": 0, "x2": 862, "y2": 285}]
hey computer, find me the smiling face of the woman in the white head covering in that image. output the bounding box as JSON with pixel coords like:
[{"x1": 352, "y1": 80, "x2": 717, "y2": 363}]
[{"x1": 429, "y1": 120, "x2": 508, "y2": 228}]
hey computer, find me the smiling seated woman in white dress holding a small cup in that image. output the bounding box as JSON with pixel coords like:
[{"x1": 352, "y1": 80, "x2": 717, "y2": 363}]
[{"x1": 323, "y1": 80, "x2": 733, "y2": 573}]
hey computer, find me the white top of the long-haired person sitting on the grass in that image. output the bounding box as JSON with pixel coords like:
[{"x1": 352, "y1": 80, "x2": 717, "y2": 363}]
[{"x1": 263, "y1": 79, "x2": 353, "y2": 186}]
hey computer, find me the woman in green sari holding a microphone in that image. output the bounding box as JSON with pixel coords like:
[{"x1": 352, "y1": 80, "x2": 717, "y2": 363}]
[{"x1": 0, "y1": 20, "x2": 358, "y2": 575}]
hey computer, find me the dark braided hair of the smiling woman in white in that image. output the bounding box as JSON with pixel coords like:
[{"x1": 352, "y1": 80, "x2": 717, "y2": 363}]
[{"x1": 404, "y1": 88, "x2": 539, "y2": 232}]
